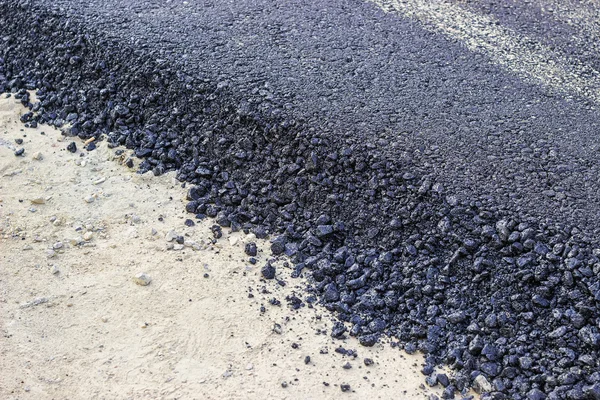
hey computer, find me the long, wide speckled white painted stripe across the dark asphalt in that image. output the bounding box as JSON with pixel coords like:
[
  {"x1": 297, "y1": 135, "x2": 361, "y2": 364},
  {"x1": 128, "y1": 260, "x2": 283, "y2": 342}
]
[{"x1": 369, "y1": 0, "x2": 600, "y2": 103}]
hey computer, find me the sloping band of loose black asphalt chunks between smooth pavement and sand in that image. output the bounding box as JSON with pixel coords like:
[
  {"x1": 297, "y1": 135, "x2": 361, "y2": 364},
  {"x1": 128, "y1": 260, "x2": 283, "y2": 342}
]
[{"x1": 0, "y1": 1, "x2": 600, "y2": 398}]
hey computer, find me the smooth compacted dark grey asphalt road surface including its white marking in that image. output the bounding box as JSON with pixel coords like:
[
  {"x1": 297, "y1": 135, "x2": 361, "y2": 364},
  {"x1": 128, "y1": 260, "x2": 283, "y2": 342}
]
[{"x1": 15, "y1": 0, "x2": 600, "y2": 234}]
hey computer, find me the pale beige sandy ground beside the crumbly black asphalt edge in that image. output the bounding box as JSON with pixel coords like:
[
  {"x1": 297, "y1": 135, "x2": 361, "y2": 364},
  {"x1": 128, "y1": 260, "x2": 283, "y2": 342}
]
[{"x1": 0, "y1": 95, "x2": 446, "y2": 399}]
